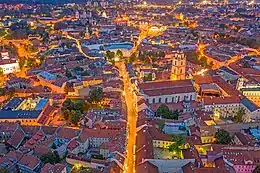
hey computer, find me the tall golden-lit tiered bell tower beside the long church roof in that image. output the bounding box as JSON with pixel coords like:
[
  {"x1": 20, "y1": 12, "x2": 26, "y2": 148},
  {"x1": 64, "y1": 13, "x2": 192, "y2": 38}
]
[{"x1": 171, "y1": 51, "x2": 186, "y2": 80}]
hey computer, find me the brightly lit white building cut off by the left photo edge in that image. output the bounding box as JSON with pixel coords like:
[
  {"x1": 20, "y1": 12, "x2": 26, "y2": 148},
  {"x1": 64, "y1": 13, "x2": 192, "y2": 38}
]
[{"x1": 0, "y1": 49, "x2": 20, "y2": 74}]
